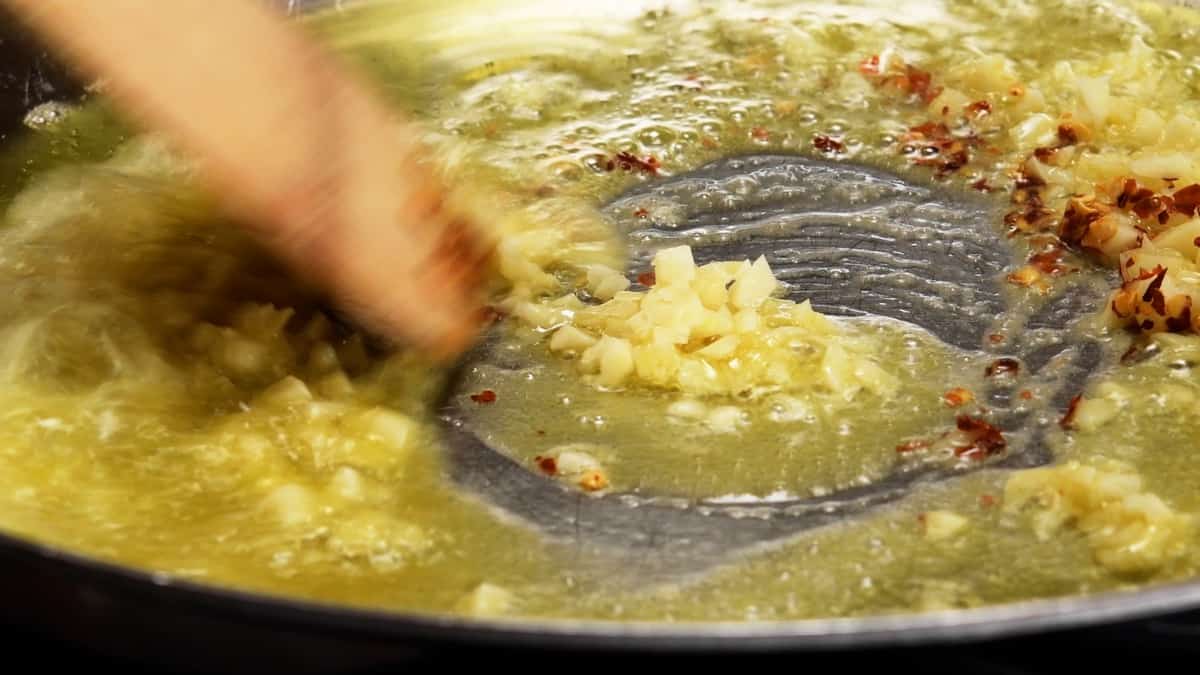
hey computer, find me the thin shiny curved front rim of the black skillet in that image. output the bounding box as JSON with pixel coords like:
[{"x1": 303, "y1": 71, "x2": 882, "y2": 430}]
[{"x1": 0, "y1": 523, "x2": 1200, "y2": 653}]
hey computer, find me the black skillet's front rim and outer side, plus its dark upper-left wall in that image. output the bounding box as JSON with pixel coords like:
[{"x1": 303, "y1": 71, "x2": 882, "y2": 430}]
[{"x1": 0, "y1": 0, "x2": 1200, "y2": 671}]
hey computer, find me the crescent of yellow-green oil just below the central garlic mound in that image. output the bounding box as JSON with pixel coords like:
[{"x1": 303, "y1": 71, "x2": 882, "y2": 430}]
[{"x1": 461, "y1": 312, "x2": 984, "y2": 500}]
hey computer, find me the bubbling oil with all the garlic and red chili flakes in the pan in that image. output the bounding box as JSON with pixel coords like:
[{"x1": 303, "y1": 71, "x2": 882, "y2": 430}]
[{"x1": 0, "y1": 0, "x2": 1200, "y2": 620}]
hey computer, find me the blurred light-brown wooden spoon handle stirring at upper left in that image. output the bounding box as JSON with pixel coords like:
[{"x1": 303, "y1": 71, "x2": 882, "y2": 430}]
[{"x1": 2, "y1": 0, "x2": 491, "y2": 357}]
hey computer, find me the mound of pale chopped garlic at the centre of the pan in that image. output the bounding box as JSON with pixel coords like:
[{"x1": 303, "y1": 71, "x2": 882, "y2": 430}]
[{"x1": 542, "y1": 246, "x2": 896, "y2": 400}]
